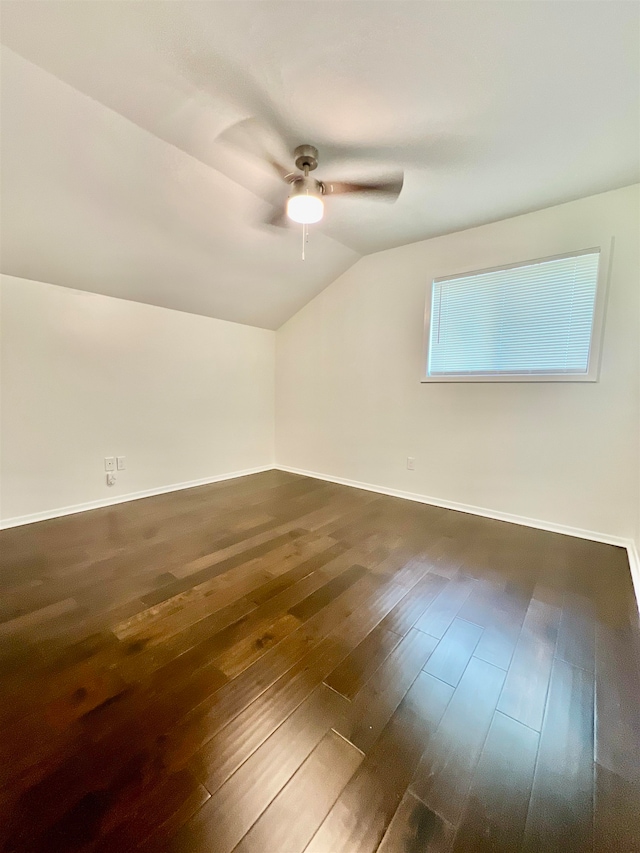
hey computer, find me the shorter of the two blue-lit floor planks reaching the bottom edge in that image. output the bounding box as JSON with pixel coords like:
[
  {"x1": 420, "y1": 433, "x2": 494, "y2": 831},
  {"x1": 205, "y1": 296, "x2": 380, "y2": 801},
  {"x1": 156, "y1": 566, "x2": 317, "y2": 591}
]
[{"x1": 453, "y1": 713, "x2": 539, "y2": 853}]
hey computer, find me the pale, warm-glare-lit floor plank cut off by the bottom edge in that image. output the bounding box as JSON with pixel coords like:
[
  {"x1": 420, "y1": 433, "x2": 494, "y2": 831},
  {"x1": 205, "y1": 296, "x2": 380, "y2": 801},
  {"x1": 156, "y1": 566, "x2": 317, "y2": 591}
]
[{"x1": 234, "y1": 731, "x2": 363, "y2": 853}]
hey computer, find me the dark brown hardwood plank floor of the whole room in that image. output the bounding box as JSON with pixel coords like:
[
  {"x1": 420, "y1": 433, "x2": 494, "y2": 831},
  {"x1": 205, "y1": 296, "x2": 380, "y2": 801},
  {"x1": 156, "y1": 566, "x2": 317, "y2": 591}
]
[{"x1": 0, "y1": 471, "x2": 640, "y2": 853}]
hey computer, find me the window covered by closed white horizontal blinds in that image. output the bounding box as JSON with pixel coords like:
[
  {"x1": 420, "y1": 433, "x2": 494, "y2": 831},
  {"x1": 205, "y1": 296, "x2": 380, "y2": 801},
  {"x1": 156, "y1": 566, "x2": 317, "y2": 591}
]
[{"x1": 425, "y1": 249, "x2": 604, "y2": 382}]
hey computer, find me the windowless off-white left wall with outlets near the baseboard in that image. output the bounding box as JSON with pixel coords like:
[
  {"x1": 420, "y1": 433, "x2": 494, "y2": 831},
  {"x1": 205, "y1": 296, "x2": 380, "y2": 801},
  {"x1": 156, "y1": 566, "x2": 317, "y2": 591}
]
[{"x1": 0, "y1": 276, "x2": 275, "y2": 522}]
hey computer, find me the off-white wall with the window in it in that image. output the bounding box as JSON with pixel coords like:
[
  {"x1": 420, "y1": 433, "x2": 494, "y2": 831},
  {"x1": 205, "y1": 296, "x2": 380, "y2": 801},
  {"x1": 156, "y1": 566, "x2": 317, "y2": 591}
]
[{"x1": 276, "y1": 186, "x2": 640, "y2": 541}]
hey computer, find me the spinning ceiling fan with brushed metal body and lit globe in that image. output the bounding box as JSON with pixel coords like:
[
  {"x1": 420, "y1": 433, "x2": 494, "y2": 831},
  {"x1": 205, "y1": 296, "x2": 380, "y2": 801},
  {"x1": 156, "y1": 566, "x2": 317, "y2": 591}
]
[{"x1": 219, "y1": 119, "x2": 404, "y2": 227}]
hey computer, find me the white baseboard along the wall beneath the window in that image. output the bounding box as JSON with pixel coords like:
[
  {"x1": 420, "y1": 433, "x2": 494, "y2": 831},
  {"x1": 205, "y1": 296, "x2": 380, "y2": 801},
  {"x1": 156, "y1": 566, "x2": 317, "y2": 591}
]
[{"x1": 275, "y1": 465, "x2": 640, "y2": 613}]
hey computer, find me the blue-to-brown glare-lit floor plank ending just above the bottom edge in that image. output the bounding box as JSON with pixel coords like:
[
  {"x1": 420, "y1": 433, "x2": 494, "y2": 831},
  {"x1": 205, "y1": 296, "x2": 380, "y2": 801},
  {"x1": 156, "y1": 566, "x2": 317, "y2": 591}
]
[{"x1": 410, "y1": 658, "x2": 505, "y2": 826}]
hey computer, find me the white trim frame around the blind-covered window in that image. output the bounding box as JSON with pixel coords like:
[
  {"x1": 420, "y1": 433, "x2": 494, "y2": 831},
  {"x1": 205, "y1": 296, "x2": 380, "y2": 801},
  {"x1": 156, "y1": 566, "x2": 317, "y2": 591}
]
[{"x1": 420, "y1": 237, "x2": 614, "y2": 383}]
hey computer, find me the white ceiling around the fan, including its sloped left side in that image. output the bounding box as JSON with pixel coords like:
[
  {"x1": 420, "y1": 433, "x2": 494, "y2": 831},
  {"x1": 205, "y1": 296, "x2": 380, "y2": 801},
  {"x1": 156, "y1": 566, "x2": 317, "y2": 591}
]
[{"x1": 0, "y1": 0, "x2": 640, "y2": 328}]
